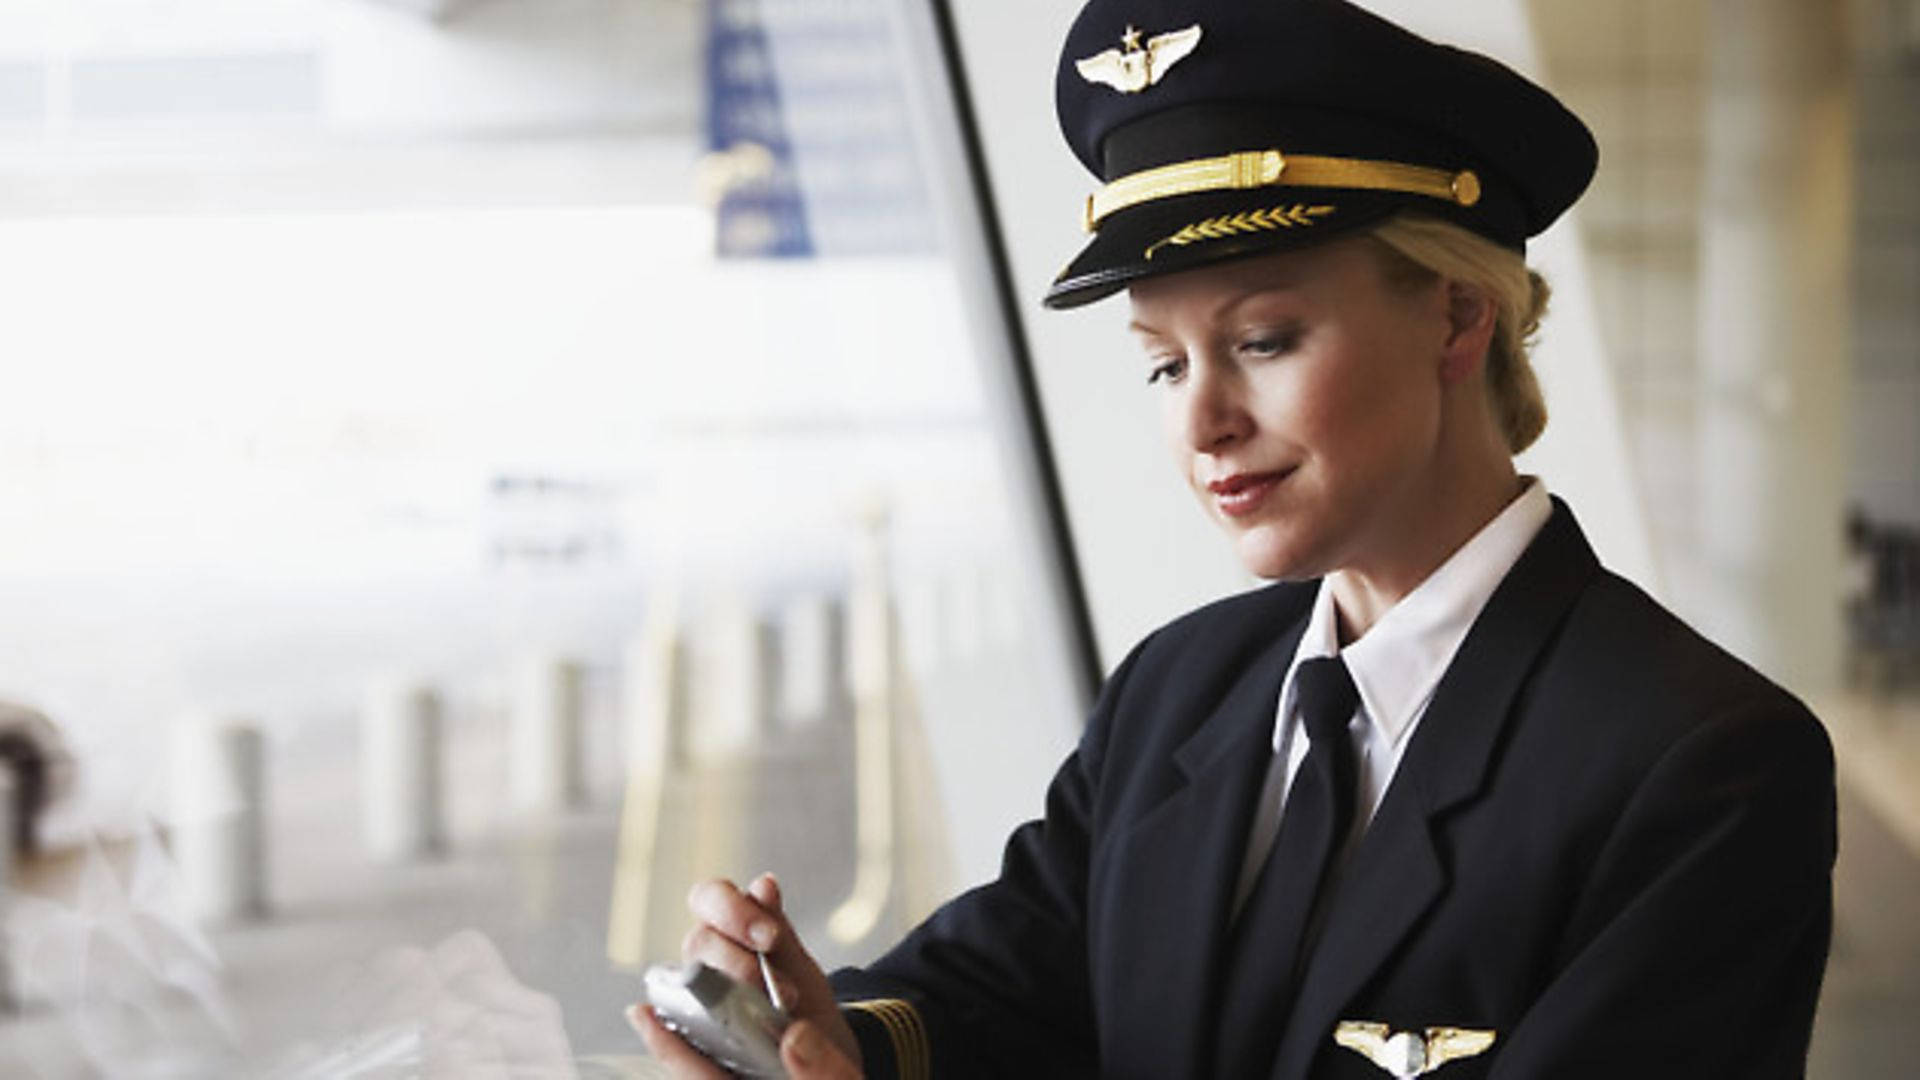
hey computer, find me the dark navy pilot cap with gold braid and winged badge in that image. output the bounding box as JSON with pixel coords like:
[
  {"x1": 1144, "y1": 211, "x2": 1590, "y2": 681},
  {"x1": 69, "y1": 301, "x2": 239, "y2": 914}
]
[{"x1": 1046, "y1": 0, "x2": 1597, "y2": 307}]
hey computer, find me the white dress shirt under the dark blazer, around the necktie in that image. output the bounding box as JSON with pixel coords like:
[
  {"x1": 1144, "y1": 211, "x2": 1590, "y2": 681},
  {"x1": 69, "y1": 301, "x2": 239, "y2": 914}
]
[{"x1": 1233, "y1": 477, "x2": 1553, "y2": 911}]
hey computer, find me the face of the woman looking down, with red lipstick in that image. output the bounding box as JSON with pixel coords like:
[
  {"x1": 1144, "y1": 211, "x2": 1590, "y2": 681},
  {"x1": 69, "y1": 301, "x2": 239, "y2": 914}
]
[{"x1": 1131, "y1": 238, "x2": 1450, "y2": 578}]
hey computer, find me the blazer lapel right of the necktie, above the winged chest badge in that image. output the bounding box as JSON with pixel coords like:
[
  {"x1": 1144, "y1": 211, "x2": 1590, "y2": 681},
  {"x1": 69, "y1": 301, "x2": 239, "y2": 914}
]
[{"x1": 1273, "y1": 498, "x2": 1599, "y2": 1080}]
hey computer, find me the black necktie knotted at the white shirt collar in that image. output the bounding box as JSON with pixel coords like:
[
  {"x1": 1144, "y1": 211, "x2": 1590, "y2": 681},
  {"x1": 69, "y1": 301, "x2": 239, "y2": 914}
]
[{"x1": 1213, "y1": 657, "x2": 1359, "y2": 1076}]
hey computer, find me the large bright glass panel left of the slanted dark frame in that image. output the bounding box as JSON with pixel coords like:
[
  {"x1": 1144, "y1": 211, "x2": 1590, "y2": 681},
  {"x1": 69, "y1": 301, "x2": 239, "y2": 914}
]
[{"x1": 0, "y1": 0, "x2": 1077, "y2": 1076}]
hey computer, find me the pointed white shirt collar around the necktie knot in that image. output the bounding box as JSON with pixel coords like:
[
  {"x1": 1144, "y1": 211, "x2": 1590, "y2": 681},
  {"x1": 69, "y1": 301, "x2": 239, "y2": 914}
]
[{"x1": 1273, "y1": 477, "x2": 1553, "y2": 748}]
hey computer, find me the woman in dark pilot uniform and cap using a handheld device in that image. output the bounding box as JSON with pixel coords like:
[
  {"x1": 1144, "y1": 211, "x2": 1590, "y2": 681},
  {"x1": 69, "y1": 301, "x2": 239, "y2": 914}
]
[{"x1": 636, "y1": 0, "x2": 1836, "y2": 1080}]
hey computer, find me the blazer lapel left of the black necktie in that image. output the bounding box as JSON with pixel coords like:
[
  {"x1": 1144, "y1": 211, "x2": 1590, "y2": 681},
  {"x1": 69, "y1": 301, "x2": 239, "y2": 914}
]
[{"x1": 1092, "y1": 595, "x2": 1306, "y2": 1076}]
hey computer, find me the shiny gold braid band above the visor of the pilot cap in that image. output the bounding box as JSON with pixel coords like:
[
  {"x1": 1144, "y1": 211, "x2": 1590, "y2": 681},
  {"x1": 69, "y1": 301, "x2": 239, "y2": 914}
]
[{"x1": 1085, "y1": 150, "x2": 1480, "y2": 233}]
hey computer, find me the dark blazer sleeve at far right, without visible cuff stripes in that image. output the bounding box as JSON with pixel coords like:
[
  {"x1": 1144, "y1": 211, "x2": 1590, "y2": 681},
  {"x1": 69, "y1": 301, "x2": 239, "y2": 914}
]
[{"x1": 1492, "y1": 696, "x2": 1836, "y2": 1080}]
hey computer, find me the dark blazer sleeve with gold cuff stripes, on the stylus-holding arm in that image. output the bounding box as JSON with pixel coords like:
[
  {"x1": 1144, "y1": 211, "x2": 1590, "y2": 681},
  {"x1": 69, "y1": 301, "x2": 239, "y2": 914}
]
[{"x1": 829, "y1": 630, "x2": 1148, "y2": 1080}]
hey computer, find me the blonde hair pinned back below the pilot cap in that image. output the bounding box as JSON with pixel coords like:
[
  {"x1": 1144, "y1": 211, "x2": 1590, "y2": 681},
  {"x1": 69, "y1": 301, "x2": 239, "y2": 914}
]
[{"x1": 1373, "y1": 213, "x2": 1551, "y2": 454}]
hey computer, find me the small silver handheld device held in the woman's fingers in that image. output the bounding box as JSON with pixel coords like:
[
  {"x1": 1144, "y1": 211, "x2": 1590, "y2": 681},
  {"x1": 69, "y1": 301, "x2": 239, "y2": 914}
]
[{"x1": 647, "y1": 961, "x2": 787, "y2": 1080}]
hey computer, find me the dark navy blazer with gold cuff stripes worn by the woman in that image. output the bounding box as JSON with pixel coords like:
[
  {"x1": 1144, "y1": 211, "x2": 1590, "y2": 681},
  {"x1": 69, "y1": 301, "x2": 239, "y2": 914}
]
[{"x1": 833, "y1": 500, "x2": 1836, "y2": 1080}]
